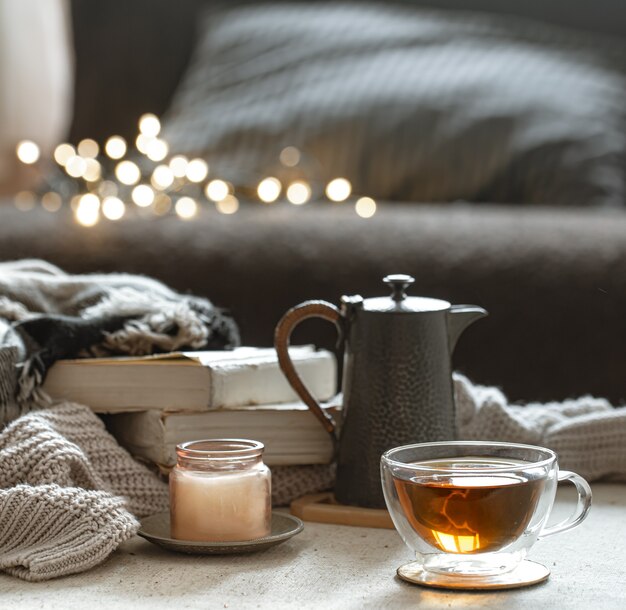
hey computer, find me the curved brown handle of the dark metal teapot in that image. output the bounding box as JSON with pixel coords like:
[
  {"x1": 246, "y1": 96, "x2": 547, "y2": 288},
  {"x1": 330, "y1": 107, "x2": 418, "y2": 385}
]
[{"x1": 274, "y1": 301, "x2": 343, "y2": 441}]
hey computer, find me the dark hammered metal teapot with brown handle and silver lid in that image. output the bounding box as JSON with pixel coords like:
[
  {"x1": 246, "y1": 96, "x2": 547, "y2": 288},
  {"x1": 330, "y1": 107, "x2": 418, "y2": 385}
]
[{"x1": 274, "y1": 275, "x2": 487, "y2": 508}]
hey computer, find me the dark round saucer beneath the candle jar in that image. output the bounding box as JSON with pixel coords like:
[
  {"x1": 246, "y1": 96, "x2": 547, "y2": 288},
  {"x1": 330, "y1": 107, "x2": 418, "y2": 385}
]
[{"x1": 137, "y1": 511, "x2": 304, "y2": 555}]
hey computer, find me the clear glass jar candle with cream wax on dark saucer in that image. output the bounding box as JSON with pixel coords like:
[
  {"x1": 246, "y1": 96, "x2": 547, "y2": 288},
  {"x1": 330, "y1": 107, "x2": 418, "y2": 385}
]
[{"x1": 170, "y1": 439, "x2": 272, "y2": 542}]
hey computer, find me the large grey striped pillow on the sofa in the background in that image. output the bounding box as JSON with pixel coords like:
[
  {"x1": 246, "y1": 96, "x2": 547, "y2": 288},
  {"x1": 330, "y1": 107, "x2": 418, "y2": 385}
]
[{"x1": 165, "y1": 2, "x2": 626, "y2": 206}]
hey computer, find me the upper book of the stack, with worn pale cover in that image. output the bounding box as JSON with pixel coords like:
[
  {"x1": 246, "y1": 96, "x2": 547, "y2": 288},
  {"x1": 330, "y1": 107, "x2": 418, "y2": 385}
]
[{"x1": 43, "y1": 345, "x2": 337, "y2": 413}]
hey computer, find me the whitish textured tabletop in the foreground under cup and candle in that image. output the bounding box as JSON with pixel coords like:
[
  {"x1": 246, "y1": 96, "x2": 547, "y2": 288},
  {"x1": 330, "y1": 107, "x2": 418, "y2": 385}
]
[{"x1": 0, "y1": 484, "x2": 626, "y2": 610}]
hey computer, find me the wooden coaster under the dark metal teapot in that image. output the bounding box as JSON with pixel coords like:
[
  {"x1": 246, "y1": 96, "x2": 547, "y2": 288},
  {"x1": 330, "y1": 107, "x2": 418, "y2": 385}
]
[{"x1": 291, "y1": 492, "x2": 393, "y2": 529}]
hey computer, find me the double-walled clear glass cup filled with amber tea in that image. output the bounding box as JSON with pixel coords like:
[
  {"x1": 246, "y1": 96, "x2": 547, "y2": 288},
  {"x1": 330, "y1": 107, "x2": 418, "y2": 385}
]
[{"x1": 381, "y1": 441, "x2": 591, "y2": 576}]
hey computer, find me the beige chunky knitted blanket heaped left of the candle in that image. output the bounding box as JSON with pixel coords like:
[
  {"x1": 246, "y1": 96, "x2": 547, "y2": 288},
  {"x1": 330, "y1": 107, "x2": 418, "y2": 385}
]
[{"x1": 0, "y1": 404, "x2": 168, "y2": 580}]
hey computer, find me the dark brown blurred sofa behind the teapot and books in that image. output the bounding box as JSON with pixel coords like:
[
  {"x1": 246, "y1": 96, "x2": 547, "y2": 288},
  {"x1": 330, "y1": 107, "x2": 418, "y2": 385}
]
[{"x1": 0, "y1": 0, "x2": 626, "y2": 404}]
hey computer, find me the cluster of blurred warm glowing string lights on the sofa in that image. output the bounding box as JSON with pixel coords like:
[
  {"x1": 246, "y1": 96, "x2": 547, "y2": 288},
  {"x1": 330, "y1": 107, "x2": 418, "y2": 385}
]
[{"x1": 15, "y1": 114, "x2": 377, "y2": 227}]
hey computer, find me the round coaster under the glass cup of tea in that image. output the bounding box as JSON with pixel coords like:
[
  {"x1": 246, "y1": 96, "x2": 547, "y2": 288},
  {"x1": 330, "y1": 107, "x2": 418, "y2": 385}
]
[{"x1": 397, "y1": 559, "x2": 550, "y2": 590}]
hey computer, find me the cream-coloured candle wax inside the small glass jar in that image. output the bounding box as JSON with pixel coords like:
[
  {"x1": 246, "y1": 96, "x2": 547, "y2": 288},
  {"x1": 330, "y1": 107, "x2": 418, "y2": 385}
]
[{"x1": 170, "y1": 470, "x2": 271, "y2": 542}]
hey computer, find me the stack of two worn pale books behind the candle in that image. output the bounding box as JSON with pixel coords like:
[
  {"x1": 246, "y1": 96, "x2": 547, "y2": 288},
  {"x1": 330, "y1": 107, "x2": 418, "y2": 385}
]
[{"x1": 43, "y1": 346, "x2": 337, "y2": 470}]
